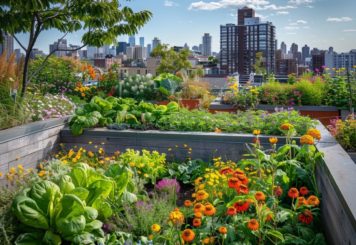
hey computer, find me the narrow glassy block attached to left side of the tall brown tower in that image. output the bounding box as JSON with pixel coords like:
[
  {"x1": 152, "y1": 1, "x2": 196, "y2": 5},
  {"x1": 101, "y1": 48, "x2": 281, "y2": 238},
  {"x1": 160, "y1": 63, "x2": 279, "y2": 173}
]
[{"x1": 220, "y1": 24, "x2": 237, "y2": 74}]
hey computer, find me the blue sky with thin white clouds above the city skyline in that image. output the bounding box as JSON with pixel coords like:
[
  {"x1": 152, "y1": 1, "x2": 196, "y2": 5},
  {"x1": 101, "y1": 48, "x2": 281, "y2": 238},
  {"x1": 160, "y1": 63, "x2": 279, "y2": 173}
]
[{"x1": 15, "y1": 0, "x2": 356, "y2": 52}]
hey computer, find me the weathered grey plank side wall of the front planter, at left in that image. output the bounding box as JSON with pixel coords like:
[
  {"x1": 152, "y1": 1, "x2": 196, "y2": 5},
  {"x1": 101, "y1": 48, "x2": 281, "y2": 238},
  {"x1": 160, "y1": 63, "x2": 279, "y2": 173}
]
[{"x1": 0, "y1": 118, "x2": 67, "y2": 186}]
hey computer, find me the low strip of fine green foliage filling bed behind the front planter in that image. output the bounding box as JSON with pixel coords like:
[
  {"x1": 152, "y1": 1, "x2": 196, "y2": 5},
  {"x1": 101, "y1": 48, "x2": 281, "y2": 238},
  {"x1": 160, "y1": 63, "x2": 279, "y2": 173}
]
[{"x1": 157, "y1": 110, "x2": 315, "y2": 135}]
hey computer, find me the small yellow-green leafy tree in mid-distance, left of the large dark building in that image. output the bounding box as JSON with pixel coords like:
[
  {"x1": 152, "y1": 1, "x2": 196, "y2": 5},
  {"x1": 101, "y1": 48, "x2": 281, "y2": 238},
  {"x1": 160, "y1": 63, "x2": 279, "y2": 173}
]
[{"x1": 151, "y1": 44, "x2": 192, "y2": 74}]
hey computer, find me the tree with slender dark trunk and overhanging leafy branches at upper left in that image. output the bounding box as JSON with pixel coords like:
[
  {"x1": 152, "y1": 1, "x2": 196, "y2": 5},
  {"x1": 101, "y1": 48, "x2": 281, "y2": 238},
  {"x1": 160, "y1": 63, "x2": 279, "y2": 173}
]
[{"x1": 0, "y1": 0, "x2": 152, "y2": 96}]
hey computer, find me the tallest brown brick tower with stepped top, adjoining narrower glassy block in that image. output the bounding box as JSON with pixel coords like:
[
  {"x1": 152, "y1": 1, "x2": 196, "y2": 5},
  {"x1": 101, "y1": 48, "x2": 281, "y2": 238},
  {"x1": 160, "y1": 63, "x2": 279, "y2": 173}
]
[{"x1": 237, "y1": 7, "x2": 276, "y2": 75}]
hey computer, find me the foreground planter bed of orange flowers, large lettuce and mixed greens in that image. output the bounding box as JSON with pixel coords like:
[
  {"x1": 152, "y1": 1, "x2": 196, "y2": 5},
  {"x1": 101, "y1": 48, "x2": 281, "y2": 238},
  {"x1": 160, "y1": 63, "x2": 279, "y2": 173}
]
[{"x1": 0, "y1": 124, "x2": 325, "y2": 244}]
